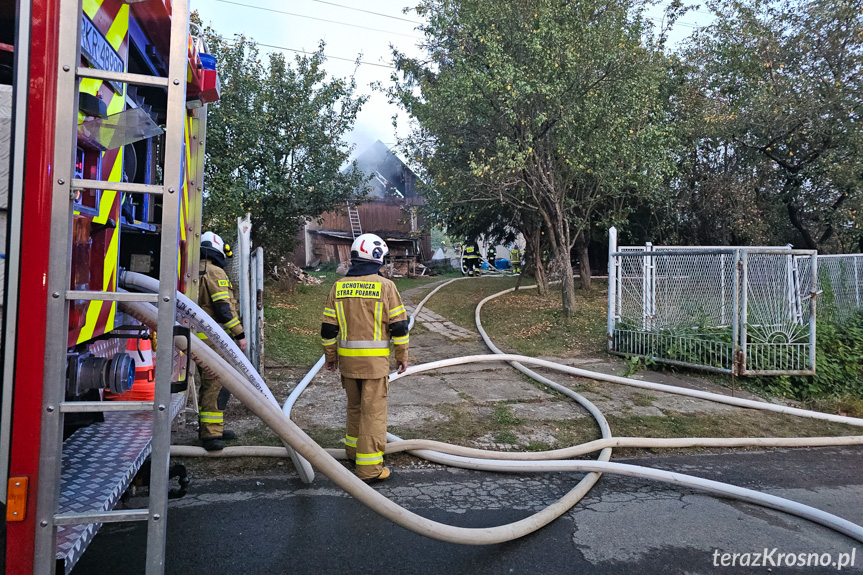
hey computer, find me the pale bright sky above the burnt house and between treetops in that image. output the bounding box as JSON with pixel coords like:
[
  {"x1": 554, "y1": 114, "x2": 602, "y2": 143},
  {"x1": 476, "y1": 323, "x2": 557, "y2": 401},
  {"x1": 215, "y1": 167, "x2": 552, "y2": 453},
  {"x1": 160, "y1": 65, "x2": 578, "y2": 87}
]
[{"x1": 191, "y1": 0, "x2": 711, "y2": 162}]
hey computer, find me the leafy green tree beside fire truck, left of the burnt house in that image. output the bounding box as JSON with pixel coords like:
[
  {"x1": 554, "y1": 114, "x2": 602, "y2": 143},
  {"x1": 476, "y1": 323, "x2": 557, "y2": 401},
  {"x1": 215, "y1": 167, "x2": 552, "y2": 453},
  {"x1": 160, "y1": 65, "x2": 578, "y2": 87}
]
[{"x1": 204, "y1": 36, "x2": 367, "y2": 262}]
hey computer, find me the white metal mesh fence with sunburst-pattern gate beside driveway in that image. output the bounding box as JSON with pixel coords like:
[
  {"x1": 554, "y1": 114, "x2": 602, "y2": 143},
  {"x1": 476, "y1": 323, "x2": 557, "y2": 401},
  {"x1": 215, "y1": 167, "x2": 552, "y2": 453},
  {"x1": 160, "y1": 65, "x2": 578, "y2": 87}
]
[{"x1": 608, "y1": 229, "x2": 816, "y2": 375}]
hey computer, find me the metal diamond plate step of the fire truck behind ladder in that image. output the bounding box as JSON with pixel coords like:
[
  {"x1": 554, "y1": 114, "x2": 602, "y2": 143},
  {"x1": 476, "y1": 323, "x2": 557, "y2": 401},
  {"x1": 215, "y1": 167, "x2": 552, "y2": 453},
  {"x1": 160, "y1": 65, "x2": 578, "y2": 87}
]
[{"x1": 57, "y1": 394, "x2": 183, "y2": 574}]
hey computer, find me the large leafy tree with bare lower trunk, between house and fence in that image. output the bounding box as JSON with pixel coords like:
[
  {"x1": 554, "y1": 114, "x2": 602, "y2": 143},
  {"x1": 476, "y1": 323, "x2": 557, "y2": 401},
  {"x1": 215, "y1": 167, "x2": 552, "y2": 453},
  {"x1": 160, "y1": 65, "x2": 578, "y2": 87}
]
[{"x1": 390, "y1": 0, "x2": 671, "y2": 317}]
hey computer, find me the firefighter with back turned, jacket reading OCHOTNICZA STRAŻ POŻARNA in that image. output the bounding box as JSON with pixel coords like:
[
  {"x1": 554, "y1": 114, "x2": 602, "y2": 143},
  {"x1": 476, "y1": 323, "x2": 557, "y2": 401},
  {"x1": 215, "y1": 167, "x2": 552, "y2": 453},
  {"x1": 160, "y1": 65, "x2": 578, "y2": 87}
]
[{"x1": 321, "y1": 234, "x2": 408, "y2": 483}]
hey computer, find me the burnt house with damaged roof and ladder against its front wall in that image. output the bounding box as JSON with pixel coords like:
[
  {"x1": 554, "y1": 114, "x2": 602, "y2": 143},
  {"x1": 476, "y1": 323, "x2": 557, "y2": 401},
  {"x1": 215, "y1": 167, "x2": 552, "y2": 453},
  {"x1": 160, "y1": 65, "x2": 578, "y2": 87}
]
[{"x1": 292, "y1": 140, "x2": 432, "y2": 266}]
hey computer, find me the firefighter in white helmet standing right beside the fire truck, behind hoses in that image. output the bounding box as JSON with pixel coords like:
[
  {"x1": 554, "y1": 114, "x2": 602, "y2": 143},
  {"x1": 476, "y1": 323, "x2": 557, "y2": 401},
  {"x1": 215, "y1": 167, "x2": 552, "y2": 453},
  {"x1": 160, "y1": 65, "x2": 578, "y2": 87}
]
[{"x1": 198, "y1": 232, "x2": 246, "y2": 451}]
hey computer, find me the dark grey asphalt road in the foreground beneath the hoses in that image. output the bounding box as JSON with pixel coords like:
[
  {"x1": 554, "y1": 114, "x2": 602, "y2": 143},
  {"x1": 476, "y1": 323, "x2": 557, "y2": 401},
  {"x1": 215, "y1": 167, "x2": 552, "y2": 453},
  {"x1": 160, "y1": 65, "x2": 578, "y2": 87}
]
[{"x1": 73, "y1": 447, "x2": 863, "y2": 575}]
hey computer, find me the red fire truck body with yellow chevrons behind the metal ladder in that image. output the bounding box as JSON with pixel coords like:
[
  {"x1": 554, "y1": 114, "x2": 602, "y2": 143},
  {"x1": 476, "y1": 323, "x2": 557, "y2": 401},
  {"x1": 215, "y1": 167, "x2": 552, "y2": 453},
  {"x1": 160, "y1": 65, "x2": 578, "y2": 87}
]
[{"x1": 0, "y1": 0, "x2": 219, "y2": 575}]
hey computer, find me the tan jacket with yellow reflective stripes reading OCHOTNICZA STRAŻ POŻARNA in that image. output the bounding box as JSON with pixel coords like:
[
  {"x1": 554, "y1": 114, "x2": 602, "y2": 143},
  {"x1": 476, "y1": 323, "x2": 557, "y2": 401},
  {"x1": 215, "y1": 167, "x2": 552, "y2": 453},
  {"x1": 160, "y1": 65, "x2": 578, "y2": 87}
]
[{"x1": 321, "y1": 275, "x2": 408, "y2": 379}]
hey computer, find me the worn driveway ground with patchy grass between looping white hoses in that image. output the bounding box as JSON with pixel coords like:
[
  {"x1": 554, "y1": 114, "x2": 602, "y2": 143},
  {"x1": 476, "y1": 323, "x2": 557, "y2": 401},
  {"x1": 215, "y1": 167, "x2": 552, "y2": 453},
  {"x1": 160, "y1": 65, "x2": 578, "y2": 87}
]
[{"x1": 175, "y1": 280, "x2": 856, "y2": 476}]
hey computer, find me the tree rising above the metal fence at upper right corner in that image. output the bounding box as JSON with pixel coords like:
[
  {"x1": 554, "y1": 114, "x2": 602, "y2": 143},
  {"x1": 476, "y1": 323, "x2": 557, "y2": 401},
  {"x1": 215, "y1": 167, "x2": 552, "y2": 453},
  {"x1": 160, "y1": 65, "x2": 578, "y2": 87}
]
[{"x1": 684, "y1": 0, "x2": 863, "y2": 251}]
